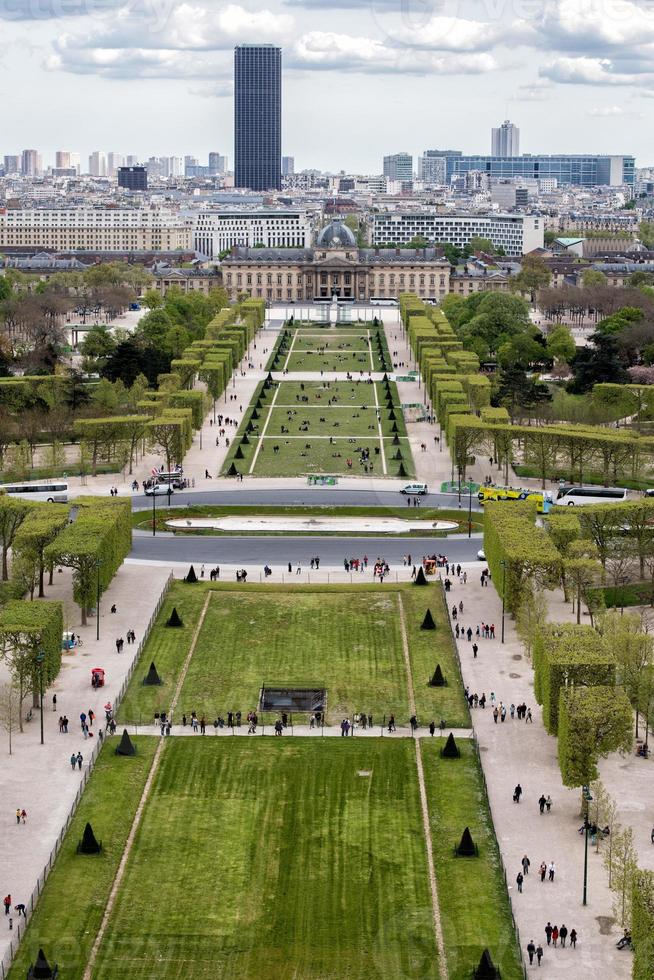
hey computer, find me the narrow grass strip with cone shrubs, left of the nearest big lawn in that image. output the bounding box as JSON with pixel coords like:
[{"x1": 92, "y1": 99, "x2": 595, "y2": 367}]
[{"x1": 8, "y1": 738, "x2": 158, "y2": 980}]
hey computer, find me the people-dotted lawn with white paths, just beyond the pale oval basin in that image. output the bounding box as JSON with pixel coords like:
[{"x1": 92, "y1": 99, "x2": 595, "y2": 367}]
[{"x1": 222, "y1": 381, "x2": 414, "y2": 478}]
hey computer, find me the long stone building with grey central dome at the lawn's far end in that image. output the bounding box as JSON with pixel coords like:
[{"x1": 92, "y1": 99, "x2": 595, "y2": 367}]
[{"x1": 221, "y1": 219, "x2": 450, "y2": 303}]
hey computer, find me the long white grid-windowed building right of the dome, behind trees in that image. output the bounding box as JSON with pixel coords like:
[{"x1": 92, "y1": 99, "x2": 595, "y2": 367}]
[{"x1": 372, "y1": 211, "x2": 544, "y2": 255}]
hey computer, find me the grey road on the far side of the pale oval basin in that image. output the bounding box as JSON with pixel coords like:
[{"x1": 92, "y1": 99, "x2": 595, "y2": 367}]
[{"x1": 132, "y1": 486, "x2": 481, "y2": 513}]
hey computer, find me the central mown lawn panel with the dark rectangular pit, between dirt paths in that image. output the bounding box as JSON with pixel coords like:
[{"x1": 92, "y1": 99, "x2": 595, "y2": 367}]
[{"x1": 178, "y1": 587, "x2": 409, "y2": 724}]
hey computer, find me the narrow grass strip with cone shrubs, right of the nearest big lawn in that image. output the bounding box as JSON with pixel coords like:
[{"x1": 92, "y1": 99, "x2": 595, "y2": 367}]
[{"x1": 421, "y1": 739, "x2": 524, "y2": 980}]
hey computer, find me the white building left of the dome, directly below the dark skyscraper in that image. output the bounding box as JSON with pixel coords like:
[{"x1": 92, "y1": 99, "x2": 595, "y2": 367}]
[{"x1": 193, "y1": 210, "x2": 311, "y2": 259}]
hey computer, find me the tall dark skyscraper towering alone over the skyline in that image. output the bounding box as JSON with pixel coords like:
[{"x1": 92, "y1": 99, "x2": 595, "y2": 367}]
[{"x1": 234, "y1": 44, "x2": 282, "y2": 191}]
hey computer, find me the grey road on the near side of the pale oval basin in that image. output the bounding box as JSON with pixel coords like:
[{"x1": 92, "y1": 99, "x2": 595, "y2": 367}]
[{"x1": 130, "y1": 533, "x2": 482, "y2": 568}]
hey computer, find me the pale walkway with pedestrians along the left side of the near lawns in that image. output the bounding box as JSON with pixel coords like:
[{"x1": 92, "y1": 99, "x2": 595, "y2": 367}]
[{"x1": 0, "y1": 563, "x2": 170, "y2": 961}]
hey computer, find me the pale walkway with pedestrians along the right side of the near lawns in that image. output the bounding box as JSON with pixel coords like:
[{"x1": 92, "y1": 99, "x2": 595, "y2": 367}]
[{"x1": 448, "y1": 566, "x2": 654, "y2": 980}]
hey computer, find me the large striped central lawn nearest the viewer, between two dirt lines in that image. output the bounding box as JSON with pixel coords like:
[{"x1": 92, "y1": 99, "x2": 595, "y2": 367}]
[{"x1": 94, "y1": 738, "x2": 438, "y2": 980}]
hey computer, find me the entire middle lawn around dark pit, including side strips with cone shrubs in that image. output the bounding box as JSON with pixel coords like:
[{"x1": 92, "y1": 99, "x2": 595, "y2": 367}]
[{"x1": 114, "y1": 582, "x2": 470, "y2": 727}]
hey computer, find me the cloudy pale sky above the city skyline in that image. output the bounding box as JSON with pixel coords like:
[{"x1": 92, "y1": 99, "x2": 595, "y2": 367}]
[{"x1": 0, "y1": 0, "x2": 654, "y2": 173}]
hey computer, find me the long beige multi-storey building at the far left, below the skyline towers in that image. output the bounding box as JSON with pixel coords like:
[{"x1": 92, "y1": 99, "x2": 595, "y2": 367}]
[{"x1": 0, "y1": 208, "x2": 193, "y2": 252}]
